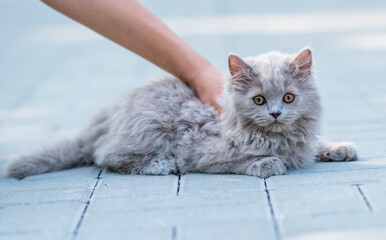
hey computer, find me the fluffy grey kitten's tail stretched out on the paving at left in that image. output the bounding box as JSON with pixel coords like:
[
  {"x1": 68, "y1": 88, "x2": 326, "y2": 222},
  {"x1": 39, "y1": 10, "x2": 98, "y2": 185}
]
[{"x1": 5, "y1": 139, "x2": 93, "y2": 179}]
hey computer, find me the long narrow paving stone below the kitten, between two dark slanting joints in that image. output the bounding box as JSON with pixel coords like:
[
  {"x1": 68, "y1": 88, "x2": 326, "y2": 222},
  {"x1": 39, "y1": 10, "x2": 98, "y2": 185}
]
[{"x1": 82, "y1": 203, "x2": 270, "y2": 231}]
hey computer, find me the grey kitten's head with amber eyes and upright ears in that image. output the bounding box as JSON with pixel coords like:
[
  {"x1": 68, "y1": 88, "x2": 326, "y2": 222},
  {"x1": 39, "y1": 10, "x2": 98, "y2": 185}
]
[{"x1": 226, "y1": 48, "x2": 321, "y2": 133}]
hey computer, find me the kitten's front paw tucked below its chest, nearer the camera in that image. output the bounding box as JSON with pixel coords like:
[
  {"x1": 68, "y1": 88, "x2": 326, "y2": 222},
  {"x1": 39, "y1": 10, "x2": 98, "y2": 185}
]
[{"x1": 247, "y1": 157, "x2": 286, "y2": 178}]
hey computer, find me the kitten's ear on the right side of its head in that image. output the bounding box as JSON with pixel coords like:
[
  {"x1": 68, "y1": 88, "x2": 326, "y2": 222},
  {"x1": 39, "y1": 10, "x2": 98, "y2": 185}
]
[{"x1": 290, "y1": 48, "x2": 312, "y2": 81}]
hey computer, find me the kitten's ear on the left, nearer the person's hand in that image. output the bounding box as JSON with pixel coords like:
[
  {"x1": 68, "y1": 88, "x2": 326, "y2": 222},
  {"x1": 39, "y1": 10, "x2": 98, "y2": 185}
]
[{"x1": 228, "y1": 54, "x2": 256, "y2": 90}]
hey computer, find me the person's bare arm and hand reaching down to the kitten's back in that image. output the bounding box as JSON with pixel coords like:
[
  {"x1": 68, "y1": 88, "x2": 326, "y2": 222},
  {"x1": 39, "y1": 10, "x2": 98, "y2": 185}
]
[{"x1": 42, "y1": 0, "x2": 223, "y2": 112}]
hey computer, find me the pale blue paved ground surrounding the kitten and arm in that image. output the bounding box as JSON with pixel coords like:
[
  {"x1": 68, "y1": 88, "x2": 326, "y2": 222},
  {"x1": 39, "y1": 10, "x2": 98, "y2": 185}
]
[{"x1": 0, "y1": 0, "x2": 386, "y2": 240}]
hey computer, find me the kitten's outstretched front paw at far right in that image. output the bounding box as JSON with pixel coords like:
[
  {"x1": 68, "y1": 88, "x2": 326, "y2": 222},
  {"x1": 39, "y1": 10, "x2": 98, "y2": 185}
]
[{"x1": 318, "y1": 142, "x2": 358, "y2": 162}]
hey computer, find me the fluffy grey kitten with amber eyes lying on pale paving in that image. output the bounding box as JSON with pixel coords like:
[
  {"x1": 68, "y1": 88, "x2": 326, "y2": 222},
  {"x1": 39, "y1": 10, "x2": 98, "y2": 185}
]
[{"x1": 6, "y1": 48, "x2": 357, "y2": 178}]
